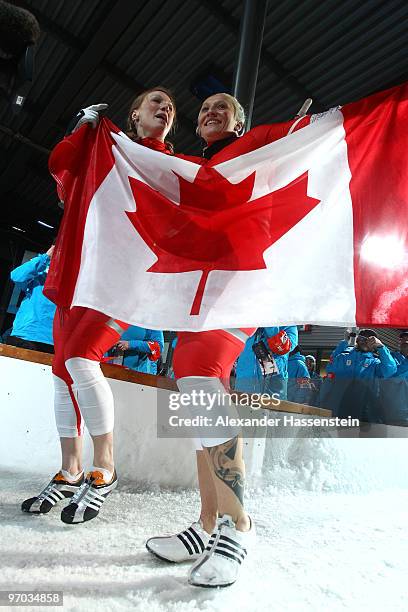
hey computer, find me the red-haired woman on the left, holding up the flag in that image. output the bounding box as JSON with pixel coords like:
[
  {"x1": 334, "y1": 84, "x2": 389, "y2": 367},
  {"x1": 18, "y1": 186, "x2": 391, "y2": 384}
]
[{"x1": 22, "y1": 87, "x2": 176, "y2": 524}]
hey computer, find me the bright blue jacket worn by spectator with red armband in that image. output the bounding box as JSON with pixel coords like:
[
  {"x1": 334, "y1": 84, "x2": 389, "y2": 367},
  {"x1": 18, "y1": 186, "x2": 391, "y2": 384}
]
[{"x1": 235, "y1": 325, "x2": 298, "y2": 399}]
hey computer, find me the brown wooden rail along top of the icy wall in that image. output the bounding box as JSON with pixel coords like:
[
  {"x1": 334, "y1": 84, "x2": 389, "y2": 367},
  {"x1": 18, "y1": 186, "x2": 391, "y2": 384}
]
[{"x1": 0, "y1": 344, "x2": 331, "y2": 417}]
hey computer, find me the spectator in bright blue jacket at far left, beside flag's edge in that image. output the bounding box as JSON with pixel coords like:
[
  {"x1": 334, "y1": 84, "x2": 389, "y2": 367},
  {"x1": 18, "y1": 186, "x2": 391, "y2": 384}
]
[{"x1": 7, "y1": 246, "x2": 55, "y2": 353}]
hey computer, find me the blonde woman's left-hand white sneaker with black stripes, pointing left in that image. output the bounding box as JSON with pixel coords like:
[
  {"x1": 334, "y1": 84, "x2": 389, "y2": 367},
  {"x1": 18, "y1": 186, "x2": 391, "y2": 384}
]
[{"x1": 146, "y1": 522, "x2": 210, "y2": 563}]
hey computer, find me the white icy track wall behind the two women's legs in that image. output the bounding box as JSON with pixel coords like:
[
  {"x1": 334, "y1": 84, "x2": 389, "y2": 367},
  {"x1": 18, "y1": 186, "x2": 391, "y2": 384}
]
[{"x1": 0, "y1": 357, "x2": 408, "y2": 492}]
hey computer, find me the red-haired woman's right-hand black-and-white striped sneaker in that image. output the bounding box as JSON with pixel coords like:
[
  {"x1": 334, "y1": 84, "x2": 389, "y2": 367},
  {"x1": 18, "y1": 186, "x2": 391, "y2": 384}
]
[{"x1": 61, "y1": 470, "x2": 118, "y2": 525}]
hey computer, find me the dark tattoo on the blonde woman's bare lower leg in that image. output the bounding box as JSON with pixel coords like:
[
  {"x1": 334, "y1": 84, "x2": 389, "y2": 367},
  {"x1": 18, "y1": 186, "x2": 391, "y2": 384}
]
[{"x1": 207, "y1": 437, "x2": 245, "y2": 506}]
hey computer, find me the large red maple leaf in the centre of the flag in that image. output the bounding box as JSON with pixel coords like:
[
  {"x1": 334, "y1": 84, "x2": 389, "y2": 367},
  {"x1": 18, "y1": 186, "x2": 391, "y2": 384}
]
[{"x1": 126, "y1": 166, "x2": 320, "y2": 315}]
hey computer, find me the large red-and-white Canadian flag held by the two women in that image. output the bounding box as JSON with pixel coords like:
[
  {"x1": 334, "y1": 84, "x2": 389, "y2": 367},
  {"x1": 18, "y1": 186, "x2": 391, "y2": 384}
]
[{"x1": 45, "y1": 85, "x2": 408, "y2": 331}]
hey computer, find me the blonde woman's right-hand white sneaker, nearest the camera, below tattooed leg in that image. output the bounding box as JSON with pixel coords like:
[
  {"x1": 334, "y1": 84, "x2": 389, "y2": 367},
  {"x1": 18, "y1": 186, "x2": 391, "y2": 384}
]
[{"x1": 188, "y1": 514, "x2": 256, "y2": 587}]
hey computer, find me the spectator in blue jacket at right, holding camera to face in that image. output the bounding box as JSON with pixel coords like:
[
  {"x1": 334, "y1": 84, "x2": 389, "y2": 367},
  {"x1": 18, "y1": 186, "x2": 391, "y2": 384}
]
[{"x1": 322, "y1": 329, "x2": 397, "y2": 423}]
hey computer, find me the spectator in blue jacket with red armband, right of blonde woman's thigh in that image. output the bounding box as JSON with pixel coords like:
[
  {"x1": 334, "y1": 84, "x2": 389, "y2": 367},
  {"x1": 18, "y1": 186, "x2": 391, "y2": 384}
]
[{"x1": 235, "y1": 325, "x2": 298, "y2": 399}]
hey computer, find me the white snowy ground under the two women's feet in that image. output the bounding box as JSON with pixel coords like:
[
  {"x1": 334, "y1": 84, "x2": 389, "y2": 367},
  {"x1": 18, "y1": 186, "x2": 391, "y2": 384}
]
[{"x1": 0, "y1": 472, "x2": 408, "y2": 612}]
